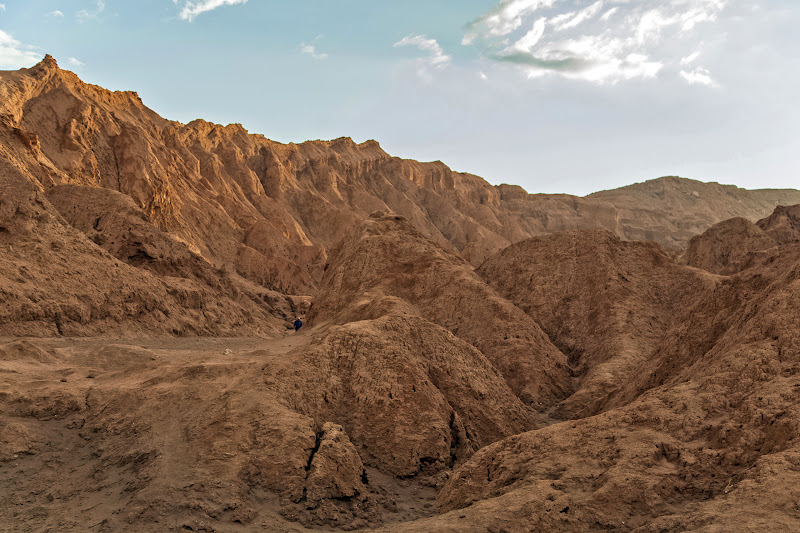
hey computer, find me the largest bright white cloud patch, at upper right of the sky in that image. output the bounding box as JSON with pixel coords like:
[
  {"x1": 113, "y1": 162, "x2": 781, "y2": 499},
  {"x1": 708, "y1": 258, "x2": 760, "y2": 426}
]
[{"x1": 462, "y1": 0, "x2": 729, "y2": 83}]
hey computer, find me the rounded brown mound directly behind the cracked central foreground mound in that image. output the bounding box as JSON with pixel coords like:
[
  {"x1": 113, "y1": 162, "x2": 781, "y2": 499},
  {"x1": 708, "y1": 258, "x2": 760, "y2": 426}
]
[{"x1": 309, "y1": 213, "x2": 572, "y2": 409}]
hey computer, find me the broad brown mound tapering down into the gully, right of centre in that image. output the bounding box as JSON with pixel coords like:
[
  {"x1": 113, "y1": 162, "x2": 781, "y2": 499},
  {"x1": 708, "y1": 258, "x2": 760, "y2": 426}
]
[{"x1": 478, "y1": 230, "x2": 715, "y2": 418}]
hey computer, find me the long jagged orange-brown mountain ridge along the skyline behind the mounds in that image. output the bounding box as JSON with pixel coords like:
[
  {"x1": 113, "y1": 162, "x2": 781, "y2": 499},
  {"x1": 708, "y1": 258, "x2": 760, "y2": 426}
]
[{"x1": 0, "y1": 56, "x2": 800, "y2": 304}]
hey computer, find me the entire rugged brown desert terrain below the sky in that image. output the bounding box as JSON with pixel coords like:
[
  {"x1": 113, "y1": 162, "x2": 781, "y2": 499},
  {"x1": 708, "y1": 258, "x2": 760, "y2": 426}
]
[{"x1": 0, "y1": 56, "x2": 800, "y2": 532}]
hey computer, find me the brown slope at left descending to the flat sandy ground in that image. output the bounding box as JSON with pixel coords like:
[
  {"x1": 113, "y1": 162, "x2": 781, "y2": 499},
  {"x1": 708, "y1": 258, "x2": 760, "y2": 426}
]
[{"x1": 0, "y1": 138, "x2": 293, "y2": 336}]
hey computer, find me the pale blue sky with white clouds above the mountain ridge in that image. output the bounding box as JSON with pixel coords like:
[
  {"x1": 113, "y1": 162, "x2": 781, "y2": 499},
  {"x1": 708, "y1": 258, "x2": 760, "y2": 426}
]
[{"x1": 0, "y1": 0, "x2": 800, "y2": 195}]
